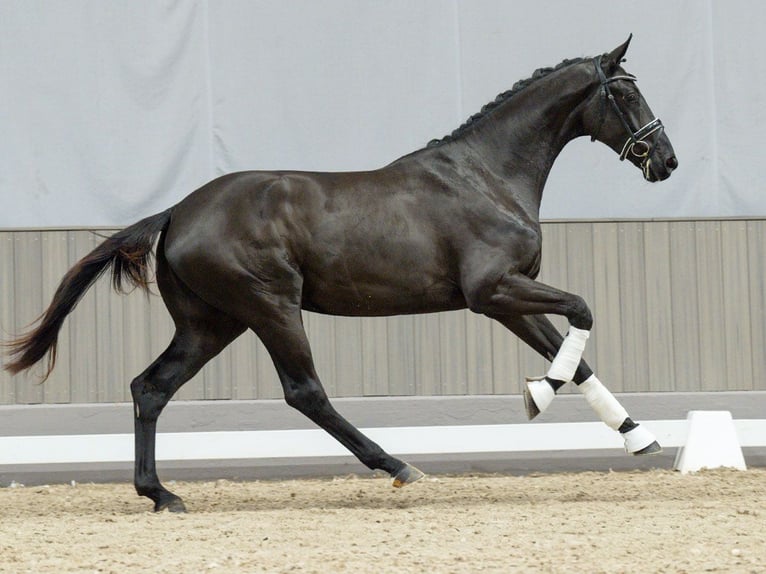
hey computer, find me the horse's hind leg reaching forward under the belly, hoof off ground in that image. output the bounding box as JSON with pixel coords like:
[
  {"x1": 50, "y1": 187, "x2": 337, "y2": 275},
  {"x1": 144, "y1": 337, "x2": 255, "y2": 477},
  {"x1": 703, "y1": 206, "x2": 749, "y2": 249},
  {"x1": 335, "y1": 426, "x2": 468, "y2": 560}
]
[{"x1": 253, "y1": 308, "x2": 423, "y2": 487}]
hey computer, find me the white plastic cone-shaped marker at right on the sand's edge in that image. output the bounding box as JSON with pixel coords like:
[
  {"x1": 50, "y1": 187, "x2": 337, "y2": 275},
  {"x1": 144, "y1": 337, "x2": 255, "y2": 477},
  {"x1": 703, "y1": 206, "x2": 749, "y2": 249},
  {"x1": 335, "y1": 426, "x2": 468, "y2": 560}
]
[{"x1": 673, "y1": 411, "x2": 747, "y2": 474}]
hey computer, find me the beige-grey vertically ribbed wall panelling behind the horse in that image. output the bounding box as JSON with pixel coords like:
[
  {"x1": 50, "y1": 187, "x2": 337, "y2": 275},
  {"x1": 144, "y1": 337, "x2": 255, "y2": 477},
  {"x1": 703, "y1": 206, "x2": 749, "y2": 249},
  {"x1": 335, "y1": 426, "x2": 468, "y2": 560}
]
[{"x1": 0, "y1": 219, "x2": 766, "y2": 404}]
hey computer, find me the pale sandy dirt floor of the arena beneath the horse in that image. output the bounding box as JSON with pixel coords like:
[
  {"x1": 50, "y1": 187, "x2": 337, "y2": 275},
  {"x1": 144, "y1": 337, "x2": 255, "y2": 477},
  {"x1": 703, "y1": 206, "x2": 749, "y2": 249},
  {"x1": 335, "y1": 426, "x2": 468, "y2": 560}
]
[{"x1": 0, "y1": 469, "x2": 766, "y2": 574}]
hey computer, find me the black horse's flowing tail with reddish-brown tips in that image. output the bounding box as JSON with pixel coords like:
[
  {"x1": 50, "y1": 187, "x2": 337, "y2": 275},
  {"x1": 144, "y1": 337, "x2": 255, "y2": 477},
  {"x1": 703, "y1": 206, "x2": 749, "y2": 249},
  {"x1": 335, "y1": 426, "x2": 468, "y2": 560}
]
[{"x1": 4, "y1": 209, "x2": 171, "y2": 380}]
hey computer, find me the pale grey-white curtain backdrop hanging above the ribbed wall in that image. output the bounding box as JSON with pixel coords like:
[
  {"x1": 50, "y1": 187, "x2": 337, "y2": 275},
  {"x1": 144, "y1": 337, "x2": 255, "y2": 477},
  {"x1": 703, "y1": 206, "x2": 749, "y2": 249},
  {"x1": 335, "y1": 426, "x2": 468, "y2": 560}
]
[{"x1": 0, "y1": 0, "x2": 766, "y2": 228}]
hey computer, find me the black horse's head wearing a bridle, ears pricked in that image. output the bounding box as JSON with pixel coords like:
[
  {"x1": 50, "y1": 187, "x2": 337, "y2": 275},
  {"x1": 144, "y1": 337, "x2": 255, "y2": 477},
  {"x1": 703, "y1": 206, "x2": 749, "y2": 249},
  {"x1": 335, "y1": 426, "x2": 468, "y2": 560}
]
[{"x1": 584, "y1": 36, "x2": 678, "y2": 182}]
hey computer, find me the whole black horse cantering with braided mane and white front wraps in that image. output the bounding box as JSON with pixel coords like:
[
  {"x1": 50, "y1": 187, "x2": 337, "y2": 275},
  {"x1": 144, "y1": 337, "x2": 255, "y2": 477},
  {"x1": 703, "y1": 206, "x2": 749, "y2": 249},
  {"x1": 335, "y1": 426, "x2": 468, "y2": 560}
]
[{"x1": 5, "y1": 38, "x2": 678, "y2": 511}]
